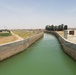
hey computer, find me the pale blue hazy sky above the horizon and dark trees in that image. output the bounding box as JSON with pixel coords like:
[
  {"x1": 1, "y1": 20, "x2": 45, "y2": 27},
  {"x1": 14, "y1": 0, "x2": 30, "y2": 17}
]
[{"x1": 0, "y1": 0, "x2": 76, "y2": 28}]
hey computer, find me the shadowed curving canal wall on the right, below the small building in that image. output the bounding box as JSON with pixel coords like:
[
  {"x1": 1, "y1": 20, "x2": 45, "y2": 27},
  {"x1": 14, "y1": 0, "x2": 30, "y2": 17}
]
[{"x1": 45, "y1": 31, "x2": 76, "y2": 60}]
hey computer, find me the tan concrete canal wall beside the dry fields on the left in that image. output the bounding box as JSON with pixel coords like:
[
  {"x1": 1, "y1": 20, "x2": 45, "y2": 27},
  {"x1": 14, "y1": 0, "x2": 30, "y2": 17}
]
[{"x1": 0, "y1": 32, "x2": 44, "y2": 61}]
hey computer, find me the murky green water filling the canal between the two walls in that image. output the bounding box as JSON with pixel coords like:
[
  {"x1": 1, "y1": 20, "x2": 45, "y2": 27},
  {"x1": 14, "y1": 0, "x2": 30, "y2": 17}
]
[{"x1": 0, "y1": 34, "x2": 76, "y2": 75}]
